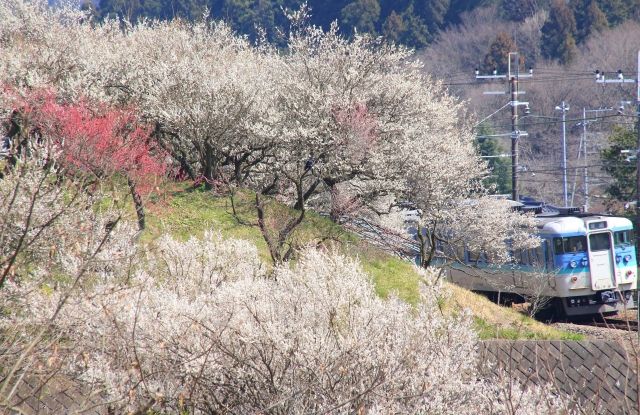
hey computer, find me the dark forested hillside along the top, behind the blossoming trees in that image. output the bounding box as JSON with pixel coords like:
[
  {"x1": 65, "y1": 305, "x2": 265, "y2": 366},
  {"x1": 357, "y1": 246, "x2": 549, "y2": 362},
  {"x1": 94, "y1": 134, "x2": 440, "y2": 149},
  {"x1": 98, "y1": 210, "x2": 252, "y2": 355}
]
[{"x1": 89, "y1": 0, "x2": 640, "y2": 55}]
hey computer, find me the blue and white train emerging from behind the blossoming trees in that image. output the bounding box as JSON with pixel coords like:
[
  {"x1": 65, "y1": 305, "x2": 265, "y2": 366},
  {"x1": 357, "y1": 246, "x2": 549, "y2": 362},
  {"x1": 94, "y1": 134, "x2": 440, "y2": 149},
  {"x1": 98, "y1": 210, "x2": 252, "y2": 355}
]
[{"x1": 448, "y1": 208, "x2": 638, "y2": 317}]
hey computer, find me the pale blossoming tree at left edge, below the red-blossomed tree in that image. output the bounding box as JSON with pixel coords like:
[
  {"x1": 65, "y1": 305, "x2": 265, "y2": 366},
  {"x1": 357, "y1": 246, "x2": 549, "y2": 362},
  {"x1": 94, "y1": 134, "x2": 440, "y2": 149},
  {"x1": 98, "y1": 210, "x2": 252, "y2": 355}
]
[{"x1": 0, "y1": 160, "x2": 136, "y2": 412}]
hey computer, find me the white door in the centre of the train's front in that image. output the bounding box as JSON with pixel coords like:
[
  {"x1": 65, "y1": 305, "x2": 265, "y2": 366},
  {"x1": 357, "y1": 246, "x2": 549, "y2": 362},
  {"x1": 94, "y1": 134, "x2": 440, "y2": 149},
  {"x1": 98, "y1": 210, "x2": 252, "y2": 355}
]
[{"x1": 589, "y1": 232, "x2": 616, "y2": 291}]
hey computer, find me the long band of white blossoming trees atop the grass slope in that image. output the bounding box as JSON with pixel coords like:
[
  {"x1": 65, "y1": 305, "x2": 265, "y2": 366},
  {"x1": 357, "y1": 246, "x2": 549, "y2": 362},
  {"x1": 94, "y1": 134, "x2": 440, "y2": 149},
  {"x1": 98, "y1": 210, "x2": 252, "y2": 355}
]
[{"x1": 0, "y1": 0, "x2": 540, "y2": 256}]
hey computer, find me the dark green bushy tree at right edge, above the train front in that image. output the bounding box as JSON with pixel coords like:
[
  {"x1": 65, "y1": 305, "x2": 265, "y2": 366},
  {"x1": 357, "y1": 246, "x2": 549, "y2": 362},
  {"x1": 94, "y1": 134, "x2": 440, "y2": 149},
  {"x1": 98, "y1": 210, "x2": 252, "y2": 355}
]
[{"x1": 600, "y1": 127, "x2": 637, "y2": 202}]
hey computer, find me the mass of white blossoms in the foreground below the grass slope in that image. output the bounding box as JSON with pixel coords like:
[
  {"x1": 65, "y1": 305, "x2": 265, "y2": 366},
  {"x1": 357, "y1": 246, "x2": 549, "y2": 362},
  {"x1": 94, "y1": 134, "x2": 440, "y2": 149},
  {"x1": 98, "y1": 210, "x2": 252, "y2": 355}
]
[{"x1": 10, "y1": 233, "x2": 562, "y2": 414}]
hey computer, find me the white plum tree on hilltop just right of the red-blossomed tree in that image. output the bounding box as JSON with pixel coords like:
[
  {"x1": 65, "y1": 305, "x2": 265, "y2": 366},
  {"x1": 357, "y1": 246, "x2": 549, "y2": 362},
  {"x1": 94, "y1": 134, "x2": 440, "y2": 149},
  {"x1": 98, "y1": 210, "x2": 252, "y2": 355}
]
[{"x1": 130, "y1": 23, "x2": 277, "y2": 184}]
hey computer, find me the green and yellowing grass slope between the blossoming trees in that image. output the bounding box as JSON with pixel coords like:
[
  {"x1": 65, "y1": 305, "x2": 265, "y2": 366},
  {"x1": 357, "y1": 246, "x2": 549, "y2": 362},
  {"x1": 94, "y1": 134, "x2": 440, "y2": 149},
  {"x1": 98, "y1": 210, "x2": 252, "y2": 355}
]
[{"x1": 143, "y1": 188, "x2": 579, "y2": 339}]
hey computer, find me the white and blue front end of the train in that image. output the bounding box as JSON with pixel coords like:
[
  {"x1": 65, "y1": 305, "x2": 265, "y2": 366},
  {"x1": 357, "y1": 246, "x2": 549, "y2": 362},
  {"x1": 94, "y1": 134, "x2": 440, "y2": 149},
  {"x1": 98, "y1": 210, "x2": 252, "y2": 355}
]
[{"x1": 545, "y1": 216, "x2": 638, "y2": 316}]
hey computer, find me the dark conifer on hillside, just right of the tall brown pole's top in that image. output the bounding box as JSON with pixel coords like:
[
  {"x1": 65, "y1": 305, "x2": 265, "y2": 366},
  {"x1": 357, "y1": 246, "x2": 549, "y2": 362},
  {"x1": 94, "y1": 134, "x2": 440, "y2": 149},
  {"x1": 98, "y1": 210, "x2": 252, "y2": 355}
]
[{"x1": 540, "y1": 0, "x2": 576, "y2": 64}]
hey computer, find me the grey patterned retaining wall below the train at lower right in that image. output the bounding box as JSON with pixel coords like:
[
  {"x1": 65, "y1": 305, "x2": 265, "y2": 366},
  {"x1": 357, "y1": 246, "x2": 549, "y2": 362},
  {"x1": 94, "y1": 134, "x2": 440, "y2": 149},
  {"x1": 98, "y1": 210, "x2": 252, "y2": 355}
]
[{"x1": 480, "y1": 340, "x2": 638, "y2": 415}]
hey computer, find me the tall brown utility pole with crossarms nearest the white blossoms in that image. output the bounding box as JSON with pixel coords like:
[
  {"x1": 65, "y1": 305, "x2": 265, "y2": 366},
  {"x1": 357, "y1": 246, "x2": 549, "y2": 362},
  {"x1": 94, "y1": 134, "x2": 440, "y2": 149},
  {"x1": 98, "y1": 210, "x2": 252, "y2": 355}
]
[{"x1": 476, "y1": 52, "x2": 533, "y2": 201}]
